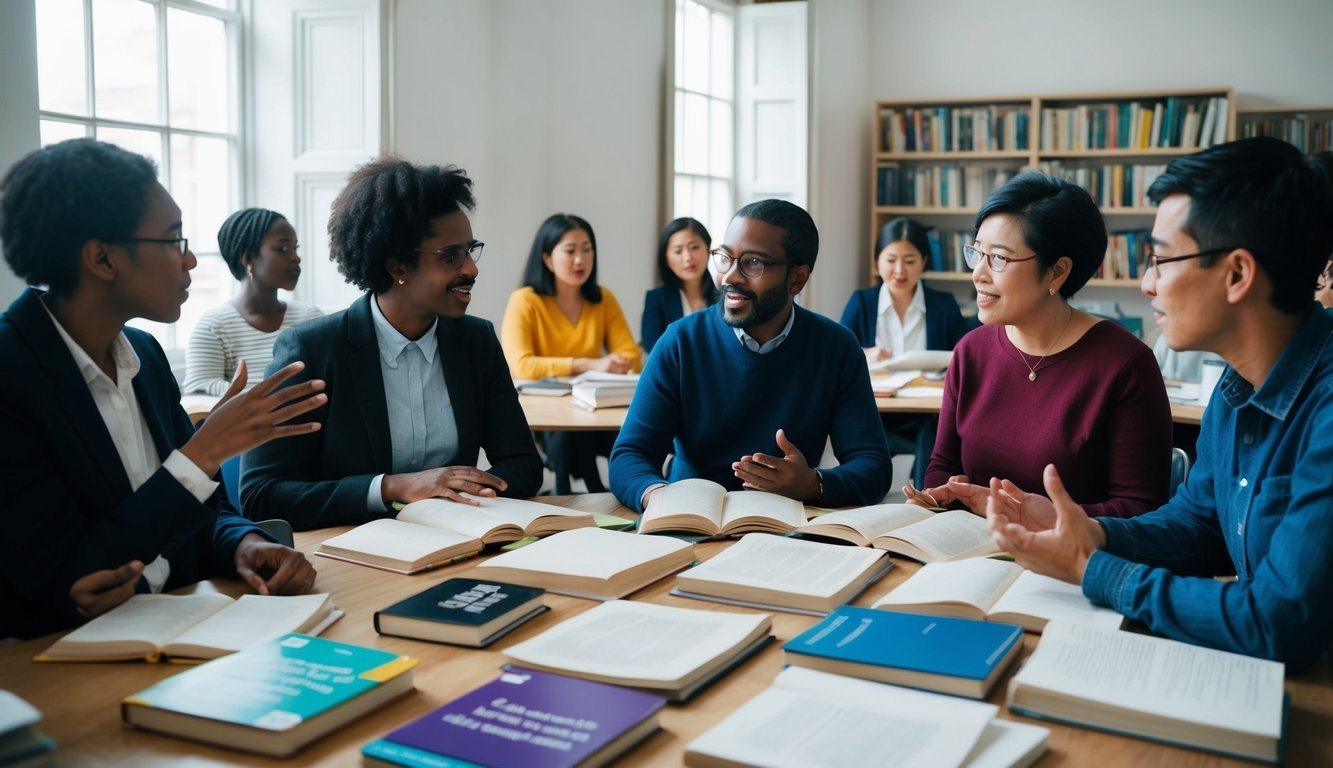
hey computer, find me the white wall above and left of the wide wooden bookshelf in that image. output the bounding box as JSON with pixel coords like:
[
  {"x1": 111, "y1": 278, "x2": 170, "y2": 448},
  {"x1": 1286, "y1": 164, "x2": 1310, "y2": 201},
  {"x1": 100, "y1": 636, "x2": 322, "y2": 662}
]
[{"x1": 810, "y1": 0, "x2": 1333, "y2": 334}]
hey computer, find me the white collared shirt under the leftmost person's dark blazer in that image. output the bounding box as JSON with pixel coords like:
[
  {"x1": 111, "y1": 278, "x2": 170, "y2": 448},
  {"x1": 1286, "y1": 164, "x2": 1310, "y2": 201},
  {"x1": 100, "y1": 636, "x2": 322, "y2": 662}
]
[{"x1": 43, "y1": 304, "x2": 217, "y2": 592}]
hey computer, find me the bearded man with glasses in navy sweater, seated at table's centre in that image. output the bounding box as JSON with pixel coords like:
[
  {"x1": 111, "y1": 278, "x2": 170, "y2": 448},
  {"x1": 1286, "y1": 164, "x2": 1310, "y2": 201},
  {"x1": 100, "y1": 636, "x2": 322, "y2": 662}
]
[{"x1": 611, "y1": 200, "x2": 892, "y2": 512}]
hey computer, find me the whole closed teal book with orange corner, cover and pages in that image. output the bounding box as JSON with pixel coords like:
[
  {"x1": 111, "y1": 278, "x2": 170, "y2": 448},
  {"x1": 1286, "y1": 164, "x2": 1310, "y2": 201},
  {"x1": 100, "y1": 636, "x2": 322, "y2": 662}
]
[{"x1": 120, "y1": 635, "x2": 417, "y2": 757}]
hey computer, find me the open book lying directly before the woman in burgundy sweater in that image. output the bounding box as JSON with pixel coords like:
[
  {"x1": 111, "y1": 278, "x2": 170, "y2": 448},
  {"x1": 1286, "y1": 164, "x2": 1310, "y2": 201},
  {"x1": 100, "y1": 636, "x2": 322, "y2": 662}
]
[{"x1": 797, "y1": 504, "x2": 1000, "y2": 563}]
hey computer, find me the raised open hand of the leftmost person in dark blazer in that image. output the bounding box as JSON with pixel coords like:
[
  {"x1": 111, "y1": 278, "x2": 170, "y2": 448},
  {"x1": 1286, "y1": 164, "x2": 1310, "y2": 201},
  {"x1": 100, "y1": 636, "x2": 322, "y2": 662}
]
[{"x1": 180, "y1": 361, "x2": 328, "y2": 477}]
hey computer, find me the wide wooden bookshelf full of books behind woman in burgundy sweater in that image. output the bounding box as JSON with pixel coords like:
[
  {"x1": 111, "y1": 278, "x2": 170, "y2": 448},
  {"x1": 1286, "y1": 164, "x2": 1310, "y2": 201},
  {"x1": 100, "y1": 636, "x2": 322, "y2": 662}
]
[{"x1": 870, "y1": 88, "x2": 1231, "y2": 291}]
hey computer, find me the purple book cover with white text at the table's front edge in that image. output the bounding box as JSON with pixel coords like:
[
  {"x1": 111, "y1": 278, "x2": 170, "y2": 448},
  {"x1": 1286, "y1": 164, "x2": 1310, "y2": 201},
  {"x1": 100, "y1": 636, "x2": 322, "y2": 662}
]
[{"x1": 384, "y1": 668, "x2": 665, "y2": 768}]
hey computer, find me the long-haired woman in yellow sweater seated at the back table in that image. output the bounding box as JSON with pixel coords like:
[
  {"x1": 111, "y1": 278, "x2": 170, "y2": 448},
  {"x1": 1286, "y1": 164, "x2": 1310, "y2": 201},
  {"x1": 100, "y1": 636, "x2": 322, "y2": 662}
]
[{"x1": 500, "y1": 213, "x2": 641, "y2": 493}]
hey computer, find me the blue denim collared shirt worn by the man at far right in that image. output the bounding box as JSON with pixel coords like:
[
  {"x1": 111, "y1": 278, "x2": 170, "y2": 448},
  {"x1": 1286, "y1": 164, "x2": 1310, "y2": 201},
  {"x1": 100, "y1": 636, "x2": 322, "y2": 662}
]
[{"x1": 1082, "y1": 311, "x2": 1333, "y2": 668}]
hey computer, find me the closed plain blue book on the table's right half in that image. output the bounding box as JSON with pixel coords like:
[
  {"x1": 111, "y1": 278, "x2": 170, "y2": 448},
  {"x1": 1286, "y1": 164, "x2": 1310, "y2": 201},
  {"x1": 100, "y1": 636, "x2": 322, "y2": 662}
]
[{"x1": 782, "y1": 605, "x2": 1022, "y2": 699}]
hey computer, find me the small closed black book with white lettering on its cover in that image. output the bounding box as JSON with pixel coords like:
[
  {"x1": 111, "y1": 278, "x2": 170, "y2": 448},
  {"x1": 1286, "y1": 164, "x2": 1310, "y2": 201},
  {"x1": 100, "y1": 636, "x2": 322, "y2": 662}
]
[{"x1": 375, "y1": 579, "x2": 547, "y2": 648}]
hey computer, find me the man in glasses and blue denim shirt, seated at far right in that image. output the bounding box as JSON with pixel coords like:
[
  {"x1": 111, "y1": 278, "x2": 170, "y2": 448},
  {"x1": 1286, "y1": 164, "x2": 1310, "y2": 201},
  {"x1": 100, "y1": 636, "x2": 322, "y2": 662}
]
[{"x1": 988, "y1": 139, "x2": 1333, "y2": 669}]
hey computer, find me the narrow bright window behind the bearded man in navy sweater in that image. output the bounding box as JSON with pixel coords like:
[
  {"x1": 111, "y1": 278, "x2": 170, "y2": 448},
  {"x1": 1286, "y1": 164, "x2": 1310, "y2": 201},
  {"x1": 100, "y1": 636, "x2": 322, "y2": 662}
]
[{"x1": 672, "y1": 0, "x2": 736, "y2": 241}]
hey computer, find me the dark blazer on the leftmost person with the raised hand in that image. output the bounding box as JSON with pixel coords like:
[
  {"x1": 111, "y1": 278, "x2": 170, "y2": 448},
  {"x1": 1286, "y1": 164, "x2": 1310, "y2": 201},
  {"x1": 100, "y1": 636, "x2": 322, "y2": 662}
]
[{"x1": 0, "y1": 288, "x2": 257, "y2": 637}]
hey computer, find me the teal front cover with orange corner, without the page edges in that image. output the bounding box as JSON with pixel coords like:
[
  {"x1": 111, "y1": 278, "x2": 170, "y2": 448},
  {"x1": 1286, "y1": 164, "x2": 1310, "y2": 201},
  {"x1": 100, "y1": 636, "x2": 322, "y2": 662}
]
[{"x1": 124, "y1": 635, "x2": 416, "y2": 732}]
